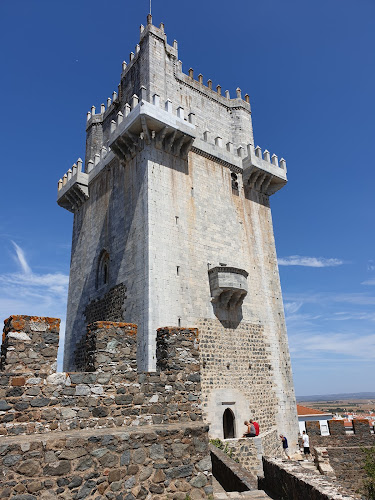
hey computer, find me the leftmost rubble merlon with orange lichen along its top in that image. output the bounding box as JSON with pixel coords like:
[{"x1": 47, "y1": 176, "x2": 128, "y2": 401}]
[{"x1": 0, "y1": 315, "x2": 60, "y2": 376}]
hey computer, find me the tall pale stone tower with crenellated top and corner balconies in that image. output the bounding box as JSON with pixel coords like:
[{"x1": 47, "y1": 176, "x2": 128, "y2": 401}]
[{"x1": 58, "y1": 16, "x2": 298, "y2": 450}]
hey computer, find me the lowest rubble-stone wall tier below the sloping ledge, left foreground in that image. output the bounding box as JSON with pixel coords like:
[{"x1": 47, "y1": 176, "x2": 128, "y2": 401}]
[{"x1": 0, "y1": 423, "x2": 212, "y2": 500}]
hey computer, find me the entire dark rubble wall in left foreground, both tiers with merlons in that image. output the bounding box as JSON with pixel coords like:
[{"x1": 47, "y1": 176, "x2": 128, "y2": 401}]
[{"x1": 0, "y1": 318, "x2": 212, "y2": 500}]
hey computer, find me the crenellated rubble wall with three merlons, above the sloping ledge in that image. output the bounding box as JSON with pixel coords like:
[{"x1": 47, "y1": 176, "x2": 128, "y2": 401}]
[{"x1": 0, "y1": 316, "x2": 202, "y2": 435}]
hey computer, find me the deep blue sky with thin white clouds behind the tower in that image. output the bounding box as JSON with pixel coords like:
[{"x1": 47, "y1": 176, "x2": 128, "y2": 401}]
[{"x1": 0, "y1": 0, "x2": 375, "y2": 395}]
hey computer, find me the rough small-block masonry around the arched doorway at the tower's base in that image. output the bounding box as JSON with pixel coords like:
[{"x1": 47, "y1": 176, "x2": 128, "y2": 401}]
[{"x1": 198, "y1": 319, "x2": 277, "y2": 438}]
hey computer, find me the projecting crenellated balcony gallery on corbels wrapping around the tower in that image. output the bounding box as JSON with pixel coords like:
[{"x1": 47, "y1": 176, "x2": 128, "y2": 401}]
[{"x1": 57, "y1": 87, "x2": 287, "y2": 212}]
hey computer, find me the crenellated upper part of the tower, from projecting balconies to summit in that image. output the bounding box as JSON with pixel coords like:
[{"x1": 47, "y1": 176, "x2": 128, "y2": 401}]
[{"x1": 57, "y1": 16, "x2": 287, "y2": 212}]
